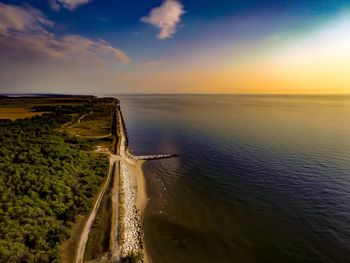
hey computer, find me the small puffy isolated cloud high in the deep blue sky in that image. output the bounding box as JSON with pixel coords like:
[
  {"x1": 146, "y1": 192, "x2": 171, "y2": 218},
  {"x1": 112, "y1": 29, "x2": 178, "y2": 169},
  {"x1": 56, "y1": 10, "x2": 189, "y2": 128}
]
[{"x1": 141, "y1": 0, "x2": 185, "y2": 39}]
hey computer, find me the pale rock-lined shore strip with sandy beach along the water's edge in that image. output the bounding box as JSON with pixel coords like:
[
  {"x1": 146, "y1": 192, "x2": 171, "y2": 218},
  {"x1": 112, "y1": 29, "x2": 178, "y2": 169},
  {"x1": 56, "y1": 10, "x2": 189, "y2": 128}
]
[{"x1": 117, "y1": 104, "x2": 149, "y2": 262}]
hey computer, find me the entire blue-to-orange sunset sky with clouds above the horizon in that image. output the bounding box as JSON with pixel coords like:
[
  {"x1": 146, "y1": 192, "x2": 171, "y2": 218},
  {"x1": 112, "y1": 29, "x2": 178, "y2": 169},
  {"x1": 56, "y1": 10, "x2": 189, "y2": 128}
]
[{"x1": 0, "y1": 0, "x2": 350, "y2": 95}]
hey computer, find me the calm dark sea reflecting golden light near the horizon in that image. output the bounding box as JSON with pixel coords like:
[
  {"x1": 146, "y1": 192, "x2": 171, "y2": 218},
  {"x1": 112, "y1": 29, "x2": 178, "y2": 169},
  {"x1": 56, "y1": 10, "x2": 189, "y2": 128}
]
[{"x1": 119, "y1": 95, "x2": 350, "y2": 263}]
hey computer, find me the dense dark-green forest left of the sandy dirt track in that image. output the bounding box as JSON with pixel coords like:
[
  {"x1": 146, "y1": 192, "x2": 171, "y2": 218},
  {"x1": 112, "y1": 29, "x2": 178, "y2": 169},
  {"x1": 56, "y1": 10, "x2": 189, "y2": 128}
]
[{"x1": 0, "y1": 106, "x2": 108, "y2": 262}]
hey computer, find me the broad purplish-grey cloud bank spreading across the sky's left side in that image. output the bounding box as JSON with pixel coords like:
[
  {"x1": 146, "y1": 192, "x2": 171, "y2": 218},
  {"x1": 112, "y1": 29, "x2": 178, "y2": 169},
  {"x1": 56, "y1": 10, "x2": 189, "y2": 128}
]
[{"x1": 0, "y1": 3, "x2": 130, "y2": 64}]
